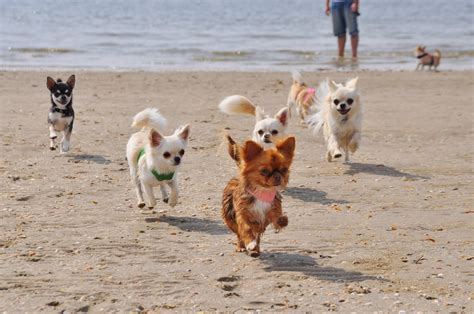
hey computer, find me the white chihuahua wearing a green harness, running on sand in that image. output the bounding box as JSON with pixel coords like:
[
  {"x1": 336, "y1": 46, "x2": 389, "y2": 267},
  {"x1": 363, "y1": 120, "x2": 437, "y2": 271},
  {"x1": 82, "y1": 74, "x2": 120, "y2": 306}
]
[{"x1": 127, "y1": 108, "x2": 190, "y2": 209}]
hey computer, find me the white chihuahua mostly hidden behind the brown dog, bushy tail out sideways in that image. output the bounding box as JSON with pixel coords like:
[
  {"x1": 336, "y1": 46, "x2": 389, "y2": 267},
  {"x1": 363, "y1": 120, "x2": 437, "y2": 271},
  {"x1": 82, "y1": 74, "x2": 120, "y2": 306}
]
[{"x1": 219, "y1": 95, "x2": 289, "y2": 150}]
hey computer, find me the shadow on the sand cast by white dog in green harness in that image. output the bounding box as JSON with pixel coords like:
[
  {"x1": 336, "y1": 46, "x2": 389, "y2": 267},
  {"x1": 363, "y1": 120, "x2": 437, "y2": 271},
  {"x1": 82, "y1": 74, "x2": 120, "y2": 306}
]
[{"x1": 145, "y1": 216, "x2": 229, "y2": 235}]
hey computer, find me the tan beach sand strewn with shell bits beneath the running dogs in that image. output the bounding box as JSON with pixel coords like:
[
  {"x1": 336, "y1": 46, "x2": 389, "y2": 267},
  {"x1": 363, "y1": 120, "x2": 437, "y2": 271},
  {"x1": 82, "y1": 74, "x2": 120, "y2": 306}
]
[{"x1": 0, "y1": 71, "x2": 474, "y2": 313}]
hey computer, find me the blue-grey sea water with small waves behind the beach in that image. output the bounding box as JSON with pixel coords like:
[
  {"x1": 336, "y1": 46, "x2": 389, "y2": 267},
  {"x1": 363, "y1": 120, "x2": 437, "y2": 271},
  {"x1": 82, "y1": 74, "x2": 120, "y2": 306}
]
[{"x1": 0, "y1": 0, "x2": 474, "y2": 71}]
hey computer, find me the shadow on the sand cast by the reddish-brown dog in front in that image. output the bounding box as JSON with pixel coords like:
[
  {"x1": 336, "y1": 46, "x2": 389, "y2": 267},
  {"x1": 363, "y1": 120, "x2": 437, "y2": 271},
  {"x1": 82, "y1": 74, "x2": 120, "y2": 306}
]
[{"x1": 260, "y1": 252, "x2": 388, "y2": 282}]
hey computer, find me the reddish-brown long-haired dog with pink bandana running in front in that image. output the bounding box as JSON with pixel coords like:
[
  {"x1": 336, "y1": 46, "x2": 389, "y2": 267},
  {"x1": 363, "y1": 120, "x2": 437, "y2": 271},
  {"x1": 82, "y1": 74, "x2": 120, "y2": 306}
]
[{"x1": 222, "y1": 137, "x2": 295, "y2": 257}]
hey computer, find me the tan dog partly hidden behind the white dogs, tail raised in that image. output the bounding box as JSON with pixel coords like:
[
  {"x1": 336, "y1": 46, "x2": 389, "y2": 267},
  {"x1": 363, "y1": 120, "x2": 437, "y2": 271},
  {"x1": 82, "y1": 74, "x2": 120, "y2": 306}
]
[{"x1": 287, "y1": 71, "x2": 316, "y2": 124}]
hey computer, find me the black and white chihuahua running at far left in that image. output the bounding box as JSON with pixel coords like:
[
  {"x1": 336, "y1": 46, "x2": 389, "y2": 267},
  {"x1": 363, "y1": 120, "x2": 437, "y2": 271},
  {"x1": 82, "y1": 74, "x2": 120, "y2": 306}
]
[{"x1": 46, "y1": 75, "x2": 76, "y2": 154}]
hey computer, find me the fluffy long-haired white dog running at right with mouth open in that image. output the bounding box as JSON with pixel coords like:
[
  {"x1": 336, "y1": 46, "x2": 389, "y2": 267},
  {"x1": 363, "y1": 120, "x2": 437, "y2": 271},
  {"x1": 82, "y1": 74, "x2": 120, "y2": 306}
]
[{"x1": 307, "y1": 77, "x2": 362, "y2": 162}]
